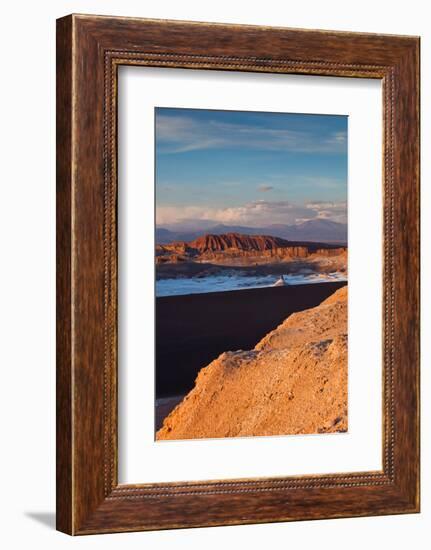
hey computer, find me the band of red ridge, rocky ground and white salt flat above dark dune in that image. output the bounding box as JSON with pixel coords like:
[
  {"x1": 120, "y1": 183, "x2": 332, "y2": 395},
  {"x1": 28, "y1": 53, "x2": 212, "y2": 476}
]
[{"x1": 156, "y1": 227, "x2": 347, "y2": 296}]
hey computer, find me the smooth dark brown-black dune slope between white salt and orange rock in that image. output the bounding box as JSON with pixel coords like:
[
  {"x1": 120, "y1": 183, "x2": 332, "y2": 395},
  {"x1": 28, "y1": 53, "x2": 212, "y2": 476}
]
[{"x1": 156, "y1": 282, "x2": 346, "y2": 399}]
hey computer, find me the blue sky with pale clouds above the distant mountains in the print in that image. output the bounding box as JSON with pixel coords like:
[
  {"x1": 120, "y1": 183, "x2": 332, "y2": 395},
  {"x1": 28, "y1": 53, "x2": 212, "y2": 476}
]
[{"x1": 156, "y1": 108, "x2": 347, "y2": 227}]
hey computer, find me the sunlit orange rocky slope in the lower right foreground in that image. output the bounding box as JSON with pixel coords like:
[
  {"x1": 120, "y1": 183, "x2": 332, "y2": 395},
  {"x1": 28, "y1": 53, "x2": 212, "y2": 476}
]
[{"x1": 156, "y1": 286, "x2": 347, "y2": 440}]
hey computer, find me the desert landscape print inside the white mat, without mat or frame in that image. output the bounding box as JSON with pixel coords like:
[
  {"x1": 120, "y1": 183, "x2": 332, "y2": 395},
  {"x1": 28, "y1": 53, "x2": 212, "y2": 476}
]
[{"x1": 154, "y1": 107, "x2": 348, "y2": 441}]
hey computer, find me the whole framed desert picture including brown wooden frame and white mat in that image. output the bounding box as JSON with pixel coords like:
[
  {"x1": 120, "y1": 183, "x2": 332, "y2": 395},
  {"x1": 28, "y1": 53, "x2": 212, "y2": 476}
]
[{"x1": 57, "y1": 15, "x2": 419, "y2": 535}]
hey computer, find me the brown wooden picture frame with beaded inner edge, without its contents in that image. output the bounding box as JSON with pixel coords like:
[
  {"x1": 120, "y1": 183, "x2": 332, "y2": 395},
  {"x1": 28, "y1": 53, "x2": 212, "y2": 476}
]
[{"x1": 57, "y1": 15, "x2": 419, "y2": 534}]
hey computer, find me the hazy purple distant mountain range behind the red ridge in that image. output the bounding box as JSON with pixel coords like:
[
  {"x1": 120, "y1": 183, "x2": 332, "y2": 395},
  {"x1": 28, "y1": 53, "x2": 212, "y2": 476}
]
[{"x1": 156, "y1": 219, "x2": 347, "y2": 244}]
